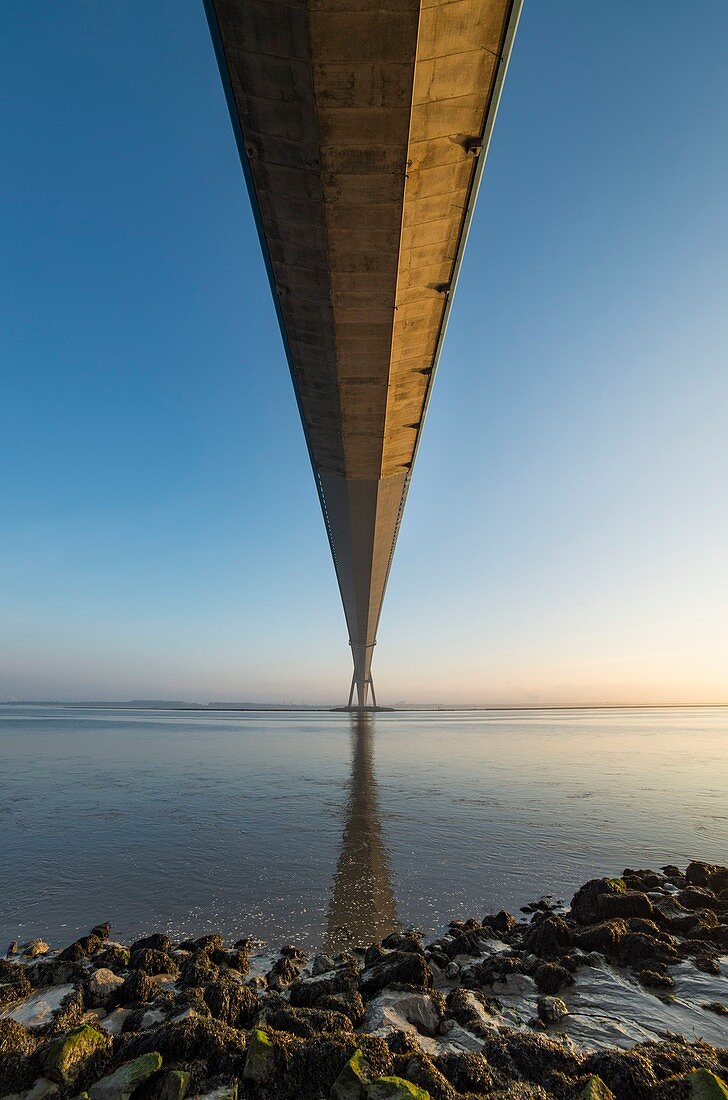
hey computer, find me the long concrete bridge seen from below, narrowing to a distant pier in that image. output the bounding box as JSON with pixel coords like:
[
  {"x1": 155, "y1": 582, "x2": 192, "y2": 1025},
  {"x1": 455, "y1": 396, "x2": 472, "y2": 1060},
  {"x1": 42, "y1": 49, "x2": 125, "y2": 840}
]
[{"x1": 205, "y1": 0, "x2": 521, "y2": 708}]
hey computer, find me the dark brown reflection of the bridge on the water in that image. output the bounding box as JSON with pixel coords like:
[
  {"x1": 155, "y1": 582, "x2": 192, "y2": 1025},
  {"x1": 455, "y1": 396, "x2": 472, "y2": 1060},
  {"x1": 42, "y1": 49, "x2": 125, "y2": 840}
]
[{"x1": 323, "y1": 714, "x2": 399, "y2": 954}]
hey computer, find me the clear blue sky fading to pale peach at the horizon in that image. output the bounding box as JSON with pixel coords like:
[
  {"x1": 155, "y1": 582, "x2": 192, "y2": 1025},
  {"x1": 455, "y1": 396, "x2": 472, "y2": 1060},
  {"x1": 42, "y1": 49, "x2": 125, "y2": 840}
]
[{"x1": 0, "y1": 0, "x2": 728, "y2": 704}]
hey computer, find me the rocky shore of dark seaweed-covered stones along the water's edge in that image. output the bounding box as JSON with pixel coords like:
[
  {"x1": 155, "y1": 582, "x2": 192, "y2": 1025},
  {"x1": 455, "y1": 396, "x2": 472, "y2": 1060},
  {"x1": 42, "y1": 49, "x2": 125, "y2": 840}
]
[{"x1": 0, "y1": 861, "x2": 728, "y2": 1100}]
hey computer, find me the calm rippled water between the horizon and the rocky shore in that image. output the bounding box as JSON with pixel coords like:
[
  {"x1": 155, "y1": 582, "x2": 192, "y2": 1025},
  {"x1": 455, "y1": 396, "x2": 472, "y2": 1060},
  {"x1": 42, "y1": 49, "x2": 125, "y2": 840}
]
[{"x1": 0, "y1": 706, "x2": 728, "y2": 946}]
